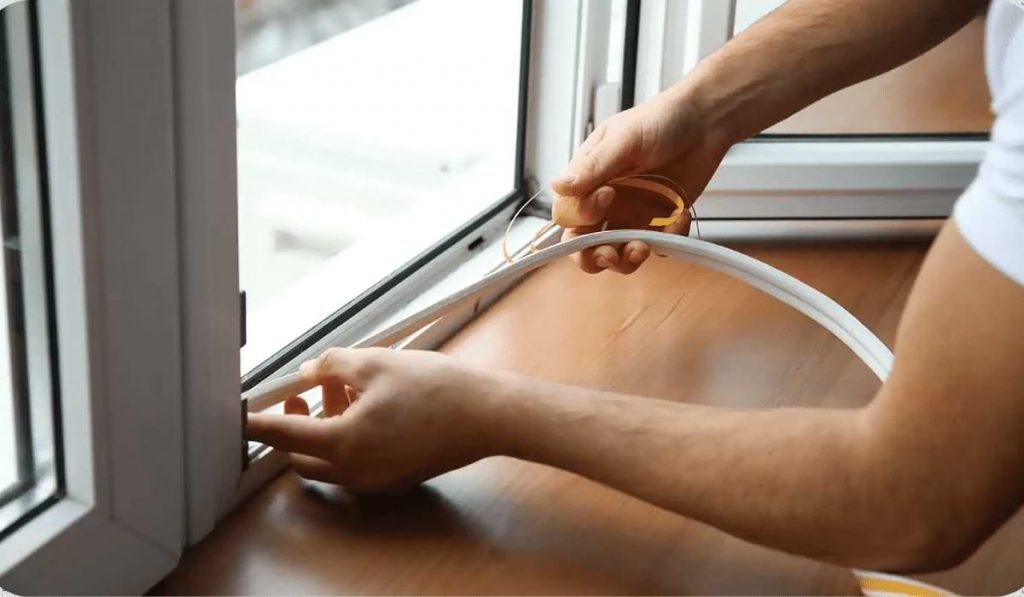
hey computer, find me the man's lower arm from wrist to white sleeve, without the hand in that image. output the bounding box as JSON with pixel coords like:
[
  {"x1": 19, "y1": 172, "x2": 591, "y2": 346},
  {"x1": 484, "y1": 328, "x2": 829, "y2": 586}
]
[{"x1": 493, "y1": 223, "x2": 1024, "y2": 571}]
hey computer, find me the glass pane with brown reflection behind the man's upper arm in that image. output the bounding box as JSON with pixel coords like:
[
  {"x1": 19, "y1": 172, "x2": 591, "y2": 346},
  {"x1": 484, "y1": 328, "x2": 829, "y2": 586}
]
[{"x1": 733, "y1": 0, "x2": 992, "y2": 135}]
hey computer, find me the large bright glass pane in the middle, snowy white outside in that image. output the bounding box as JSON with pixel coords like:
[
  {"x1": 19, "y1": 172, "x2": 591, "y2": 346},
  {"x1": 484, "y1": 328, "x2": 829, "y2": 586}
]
[{"x1": 236, "y1": 0, "x2": 523, "y2": 372}]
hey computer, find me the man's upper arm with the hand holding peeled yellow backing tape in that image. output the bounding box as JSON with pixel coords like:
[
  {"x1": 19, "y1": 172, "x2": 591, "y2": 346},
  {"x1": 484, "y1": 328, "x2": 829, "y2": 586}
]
[{"x1": 552, "y1": 0, "x2": 988, "y2": 273}]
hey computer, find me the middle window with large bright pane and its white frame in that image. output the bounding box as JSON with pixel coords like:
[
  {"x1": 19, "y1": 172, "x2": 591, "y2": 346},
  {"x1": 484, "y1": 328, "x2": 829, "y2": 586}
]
[{"x1": 184, "y1": 0, "x2": 608, "y2": 557}]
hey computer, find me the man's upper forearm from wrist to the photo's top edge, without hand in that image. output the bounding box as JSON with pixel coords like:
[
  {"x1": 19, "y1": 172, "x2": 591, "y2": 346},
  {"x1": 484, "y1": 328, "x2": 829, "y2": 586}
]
[{"x1": 666, "y1": 0, "x2": 987, "y2": 142}]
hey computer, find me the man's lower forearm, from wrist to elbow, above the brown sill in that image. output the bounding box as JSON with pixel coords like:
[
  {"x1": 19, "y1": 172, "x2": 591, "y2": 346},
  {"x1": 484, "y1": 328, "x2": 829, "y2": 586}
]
[{"x1": 491, "y1": 381, "x2": 919, "y2": 567}]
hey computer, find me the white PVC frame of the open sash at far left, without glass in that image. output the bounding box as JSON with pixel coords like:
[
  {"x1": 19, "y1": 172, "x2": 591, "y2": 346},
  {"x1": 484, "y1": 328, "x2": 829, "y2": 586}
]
[{"x1": 0, "y1": 0, "x2": 185, "y2": 594}]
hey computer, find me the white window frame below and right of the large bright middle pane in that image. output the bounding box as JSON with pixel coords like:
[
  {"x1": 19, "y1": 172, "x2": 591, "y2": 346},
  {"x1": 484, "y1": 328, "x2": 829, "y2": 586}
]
[{"x1": 232, "y1": 0, "x2": 610, "y2": 509}]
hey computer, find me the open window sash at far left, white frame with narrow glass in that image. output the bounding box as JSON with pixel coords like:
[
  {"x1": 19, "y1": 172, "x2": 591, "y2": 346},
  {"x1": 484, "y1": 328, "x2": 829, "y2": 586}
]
[{"x1": 0, "y1": 0, "x2": 185, "y2": 594}]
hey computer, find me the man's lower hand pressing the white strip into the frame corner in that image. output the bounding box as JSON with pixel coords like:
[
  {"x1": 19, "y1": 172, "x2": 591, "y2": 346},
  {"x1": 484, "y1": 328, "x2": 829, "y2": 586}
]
[{"x1": 247, "y1": 348, "x2": 507, "y2": 492}]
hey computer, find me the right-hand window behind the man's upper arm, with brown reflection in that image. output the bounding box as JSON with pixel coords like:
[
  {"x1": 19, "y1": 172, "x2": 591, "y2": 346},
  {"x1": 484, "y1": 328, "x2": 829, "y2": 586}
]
[{"x1": 637, "y1": 0, "x2": 991, "y2": 225}]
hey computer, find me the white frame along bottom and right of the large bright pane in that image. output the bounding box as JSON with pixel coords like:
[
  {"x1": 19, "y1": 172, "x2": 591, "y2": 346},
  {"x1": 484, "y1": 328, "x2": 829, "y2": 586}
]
[{"x1": 232, "y1": 0, "x2": 610, "y2": 503}]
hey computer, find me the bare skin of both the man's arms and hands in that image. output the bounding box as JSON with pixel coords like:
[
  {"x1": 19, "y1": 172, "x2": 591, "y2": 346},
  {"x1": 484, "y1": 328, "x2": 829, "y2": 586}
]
[{"x1": 248, "y1": 0, "x2": 1024, "y2": 571}]
